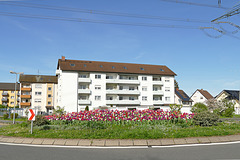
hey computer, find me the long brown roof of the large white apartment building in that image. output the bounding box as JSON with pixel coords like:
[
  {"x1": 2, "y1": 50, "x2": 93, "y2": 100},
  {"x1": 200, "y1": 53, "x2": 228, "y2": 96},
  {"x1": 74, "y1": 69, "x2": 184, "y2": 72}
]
[{"x1": 57, "y1": 56, "x2": 176, "y2": 76}]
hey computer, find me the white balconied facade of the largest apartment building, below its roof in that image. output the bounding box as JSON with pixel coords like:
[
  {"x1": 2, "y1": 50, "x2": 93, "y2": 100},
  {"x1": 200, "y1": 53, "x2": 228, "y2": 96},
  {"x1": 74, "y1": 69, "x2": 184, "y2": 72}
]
[{"x1": 56, "y1": 69, "x2": 174, "y2": 112}]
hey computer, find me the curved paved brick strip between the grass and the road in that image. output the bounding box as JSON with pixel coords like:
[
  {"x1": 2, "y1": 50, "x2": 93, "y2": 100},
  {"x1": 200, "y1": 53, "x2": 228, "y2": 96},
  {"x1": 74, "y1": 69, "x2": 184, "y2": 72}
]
[{"x1": 0, "y1": 135, "x2": 240, "y2": 147}]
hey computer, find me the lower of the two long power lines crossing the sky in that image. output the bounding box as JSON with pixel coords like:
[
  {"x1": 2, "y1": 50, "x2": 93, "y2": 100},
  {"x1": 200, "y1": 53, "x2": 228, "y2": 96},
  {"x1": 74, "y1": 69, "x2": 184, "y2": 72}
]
[{"x1": 0, "y1": 12, "x2": 199, "y2": 29}]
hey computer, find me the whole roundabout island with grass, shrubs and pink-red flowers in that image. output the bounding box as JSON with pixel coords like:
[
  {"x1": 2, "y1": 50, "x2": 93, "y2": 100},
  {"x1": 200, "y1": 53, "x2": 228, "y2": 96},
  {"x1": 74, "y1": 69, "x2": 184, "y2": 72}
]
[{"x1": 0, "y1": 110, "x2": 240, "y2": 139}]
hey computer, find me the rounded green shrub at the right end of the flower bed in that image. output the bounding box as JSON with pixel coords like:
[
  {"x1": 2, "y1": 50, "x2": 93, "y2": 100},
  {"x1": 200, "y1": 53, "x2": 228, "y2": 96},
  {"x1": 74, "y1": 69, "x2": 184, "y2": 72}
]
[{"x1": 193, "y1": 111, "x2": 219, "y2": 126}]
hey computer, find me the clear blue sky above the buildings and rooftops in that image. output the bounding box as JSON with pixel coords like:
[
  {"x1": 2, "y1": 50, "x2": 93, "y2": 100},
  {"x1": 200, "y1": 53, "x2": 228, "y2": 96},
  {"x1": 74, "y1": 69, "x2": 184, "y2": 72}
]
[{"x1": 0, "y1": 0, "x2": 240, "y2": 96}]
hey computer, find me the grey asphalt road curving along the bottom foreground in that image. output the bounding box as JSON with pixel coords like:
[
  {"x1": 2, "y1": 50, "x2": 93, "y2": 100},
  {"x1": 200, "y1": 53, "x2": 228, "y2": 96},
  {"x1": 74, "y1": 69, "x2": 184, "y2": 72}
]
[{"x1": 0, "y1": 143, "x2": 240, "y2": 160}]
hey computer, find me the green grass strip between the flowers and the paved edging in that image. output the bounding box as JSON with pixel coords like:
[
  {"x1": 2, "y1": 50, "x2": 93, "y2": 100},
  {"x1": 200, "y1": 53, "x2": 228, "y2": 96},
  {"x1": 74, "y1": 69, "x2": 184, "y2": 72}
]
[{"x1": 0, "y1": 122, "x2": 240, "y2": 139}]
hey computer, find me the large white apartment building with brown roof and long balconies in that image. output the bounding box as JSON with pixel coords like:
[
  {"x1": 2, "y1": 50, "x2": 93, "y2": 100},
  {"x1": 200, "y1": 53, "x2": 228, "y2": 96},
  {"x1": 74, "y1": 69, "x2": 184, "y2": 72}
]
[{"x1": 56, "y1": 57, "x2": 176, "y2": 112}]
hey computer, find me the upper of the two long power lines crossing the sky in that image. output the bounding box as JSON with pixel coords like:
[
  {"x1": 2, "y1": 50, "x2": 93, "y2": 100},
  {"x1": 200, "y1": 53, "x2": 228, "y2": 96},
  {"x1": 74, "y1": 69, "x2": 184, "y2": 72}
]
[{"x1": 0, "y1": 1, "x2": 209, "y2": 23}]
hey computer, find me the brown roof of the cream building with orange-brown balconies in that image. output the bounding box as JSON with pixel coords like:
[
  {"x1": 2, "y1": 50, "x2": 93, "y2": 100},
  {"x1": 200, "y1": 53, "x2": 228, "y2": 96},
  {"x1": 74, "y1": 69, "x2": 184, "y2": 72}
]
[{"x1": 19, "y1": 74, "x2": 58, "y2": 84}]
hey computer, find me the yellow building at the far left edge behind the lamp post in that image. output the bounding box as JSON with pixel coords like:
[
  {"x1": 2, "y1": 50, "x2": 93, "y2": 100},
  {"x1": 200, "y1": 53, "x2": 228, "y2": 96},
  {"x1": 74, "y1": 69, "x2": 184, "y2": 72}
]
[{"x1": 0, "y1": 83, "x2": 20, "y2": 107}]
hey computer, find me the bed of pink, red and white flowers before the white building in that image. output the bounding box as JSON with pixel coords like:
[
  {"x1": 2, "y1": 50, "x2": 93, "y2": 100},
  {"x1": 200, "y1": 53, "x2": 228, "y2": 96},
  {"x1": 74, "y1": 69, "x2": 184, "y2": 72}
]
[{"x1": 46, "y1": 109, "x2": 193, "y2": 121}]
